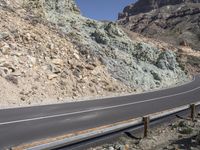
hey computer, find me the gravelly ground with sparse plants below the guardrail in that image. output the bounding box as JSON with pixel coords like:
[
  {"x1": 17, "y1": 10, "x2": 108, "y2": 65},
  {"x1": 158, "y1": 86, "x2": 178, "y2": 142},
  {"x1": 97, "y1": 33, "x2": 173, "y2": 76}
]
[{"x1": 89, "y1": 112, "x2": 200, "y2": 150}]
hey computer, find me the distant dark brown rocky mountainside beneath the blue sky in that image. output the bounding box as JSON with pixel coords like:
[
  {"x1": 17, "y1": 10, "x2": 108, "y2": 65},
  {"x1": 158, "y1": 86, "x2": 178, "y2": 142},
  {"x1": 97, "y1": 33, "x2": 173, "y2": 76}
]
[{"x1": 118, "y1": 0, "x2": 200, "y2": 50}]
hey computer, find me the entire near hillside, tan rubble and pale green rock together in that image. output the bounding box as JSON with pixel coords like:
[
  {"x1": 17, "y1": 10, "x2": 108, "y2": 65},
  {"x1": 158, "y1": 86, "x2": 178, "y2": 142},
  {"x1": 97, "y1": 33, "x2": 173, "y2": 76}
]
[{"x1": 0, "y1": 0, "x2": 188, "y2": 106}]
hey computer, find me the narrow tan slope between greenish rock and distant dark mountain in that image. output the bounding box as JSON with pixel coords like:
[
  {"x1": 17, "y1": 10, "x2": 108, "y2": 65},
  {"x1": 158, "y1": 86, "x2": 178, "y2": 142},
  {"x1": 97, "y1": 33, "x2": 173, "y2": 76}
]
[{"x1": 122, "y1": 27, "x2": 200, "y2": 75}]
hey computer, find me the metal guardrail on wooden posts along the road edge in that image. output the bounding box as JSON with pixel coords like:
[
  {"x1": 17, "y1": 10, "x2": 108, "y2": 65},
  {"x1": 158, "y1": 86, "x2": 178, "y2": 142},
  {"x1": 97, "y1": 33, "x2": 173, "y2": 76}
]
[{"x1": 27, "y1": 102, "x2": 200, "y2": 150}]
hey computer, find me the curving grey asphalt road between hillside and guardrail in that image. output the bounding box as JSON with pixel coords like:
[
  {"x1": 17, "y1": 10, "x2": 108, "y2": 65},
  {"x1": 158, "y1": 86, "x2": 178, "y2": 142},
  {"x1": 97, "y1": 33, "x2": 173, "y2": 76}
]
[{"x1": 0, "y1": 76, "x2": 200, "y2": 149}]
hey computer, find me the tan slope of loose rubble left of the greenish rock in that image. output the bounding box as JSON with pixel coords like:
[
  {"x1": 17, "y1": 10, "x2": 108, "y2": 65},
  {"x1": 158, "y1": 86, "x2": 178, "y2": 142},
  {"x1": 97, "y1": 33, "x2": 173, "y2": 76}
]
[{"x1": 0, "y1": 1, "x2": 131, "y2": 107}]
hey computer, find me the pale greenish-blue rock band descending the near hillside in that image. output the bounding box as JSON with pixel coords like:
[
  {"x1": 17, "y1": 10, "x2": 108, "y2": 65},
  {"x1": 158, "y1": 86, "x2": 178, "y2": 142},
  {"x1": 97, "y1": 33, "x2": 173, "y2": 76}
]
[{"x1": 21, "y1": 0, "x2": 188, "y2": 90}]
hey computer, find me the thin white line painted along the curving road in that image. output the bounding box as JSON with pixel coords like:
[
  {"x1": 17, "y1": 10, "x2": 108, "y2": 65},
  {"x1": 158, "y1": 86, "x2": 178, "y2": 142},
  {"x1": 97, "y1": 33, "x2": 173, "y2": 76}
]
[{"x1": 0, "y1": 87, "x2": 200, "y2": 126}]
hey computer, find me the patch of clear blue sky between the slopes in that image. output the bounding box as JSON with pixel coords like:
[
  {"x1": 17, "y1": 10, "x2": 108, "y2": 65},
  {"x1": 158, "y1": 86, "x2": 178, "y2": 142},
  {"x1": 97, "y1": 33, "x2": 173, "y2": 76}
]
[{"x1": 75, "y1": 0, "x2": 135, "y2": 21}]
